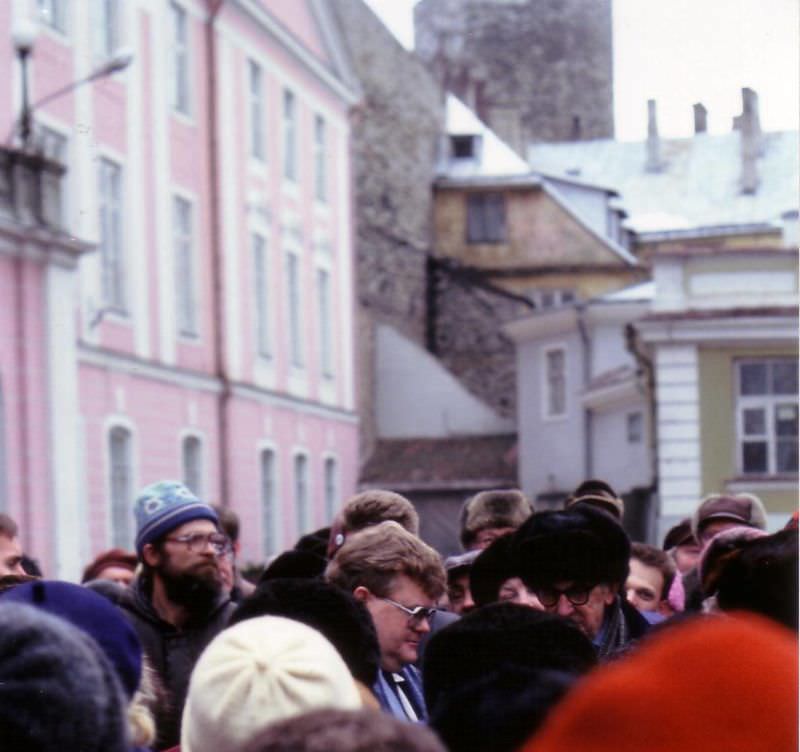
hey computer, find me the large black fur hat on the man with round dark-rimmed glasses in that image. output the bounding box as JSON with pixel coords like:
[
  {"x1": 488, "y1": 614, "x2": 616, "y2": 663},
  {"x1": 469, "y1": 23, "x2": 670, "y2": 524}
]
[{"x1": 512, "y1": 504, "x2": 631, "y2": 590}]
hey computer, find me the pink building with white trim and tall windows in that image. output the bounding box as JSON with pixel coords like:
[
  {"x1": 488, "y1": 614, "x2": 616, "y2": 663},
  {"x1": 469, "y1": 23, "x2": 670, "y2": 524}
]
[{"x1": 0, "y1": 0, "x2": 358, "y2": 578}]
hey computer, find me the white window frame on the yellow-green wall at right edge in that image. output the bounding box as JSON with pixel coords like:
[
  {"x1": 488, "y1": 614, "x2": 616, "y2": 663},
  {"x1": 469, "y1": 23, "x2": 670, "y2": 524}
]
[{"x1": 734, "y1": 356, "x2": 798, "y2": 478}]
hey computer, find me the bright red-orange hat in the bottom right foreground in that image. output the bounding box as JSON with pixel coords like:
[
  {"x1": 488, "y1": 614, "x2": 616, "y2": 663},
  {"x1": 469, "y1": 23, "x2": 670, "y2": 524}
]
[{"x1": 522, "y1": 613, "x2": 798, "y2": 752}]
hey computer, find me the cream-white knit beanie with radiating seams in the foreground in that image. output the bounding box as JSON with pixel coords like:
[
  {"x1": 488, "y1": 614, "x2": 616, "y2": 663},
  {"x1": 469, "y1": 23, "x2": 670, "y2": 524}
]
[{"x1": 181, "y1": 616, "x2": 361, "y2": 752}]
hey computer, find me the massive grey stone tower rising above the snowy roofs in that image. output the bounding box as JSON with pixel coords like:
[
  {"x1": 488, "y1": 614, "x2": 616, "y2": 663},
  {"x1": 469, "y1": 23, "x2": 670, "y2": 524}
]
[{"x1": 414, "y1": 0, "x2": 614, "y2": 156}]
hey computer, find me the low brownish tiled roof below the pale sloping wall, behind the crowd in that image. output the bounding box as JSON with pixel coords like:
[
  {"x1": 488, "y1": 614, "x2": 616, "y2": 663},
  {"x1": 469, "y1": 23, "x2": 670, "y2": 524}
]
[{"x1": 360, "y1": 434, "x2": 517, "y2": 491}]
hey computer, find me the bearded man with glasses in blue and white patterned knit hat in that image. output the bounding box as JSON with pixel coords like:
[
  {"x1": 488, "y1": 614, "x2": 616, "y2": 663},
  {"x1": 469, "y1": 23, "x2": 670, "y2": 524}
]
[{"x1": 119, "y1": 481, "x2": 234, "y2": 749}]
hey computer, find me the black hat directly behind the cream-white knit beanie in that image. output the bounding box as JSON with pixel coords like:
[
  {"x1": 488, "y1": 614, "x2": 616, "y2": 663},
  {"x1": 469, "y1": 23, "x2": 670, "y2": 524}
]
[{"x1": 229, "y1": 578, "x2": 380, "y2": 687}]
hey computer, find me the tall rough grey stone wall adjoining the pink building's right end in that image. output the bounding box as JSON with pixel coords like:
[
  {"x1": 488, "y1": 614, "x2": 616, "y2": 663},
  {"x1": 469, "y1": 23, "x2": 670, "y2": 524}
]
[{"x1": 330, "y1": 0, "x2": 444, "y2": 458}]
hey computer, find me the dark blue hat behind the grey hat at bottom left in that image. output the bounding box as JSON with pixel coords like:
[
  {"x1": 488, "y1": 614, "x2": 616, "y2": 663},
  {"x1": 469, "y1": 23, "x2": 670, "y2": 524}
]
[{"x1": 0, "y1": 580, "x2": 142, "y2": 699}]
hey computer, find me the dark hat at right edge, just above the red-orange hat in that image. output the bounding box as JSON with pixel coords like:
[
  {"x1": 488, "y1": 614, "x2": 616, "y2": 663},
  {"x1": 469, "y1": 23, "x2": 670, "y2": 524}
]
[{"x1": 717, "y1": 530, "x2": 799, "y2": 630}]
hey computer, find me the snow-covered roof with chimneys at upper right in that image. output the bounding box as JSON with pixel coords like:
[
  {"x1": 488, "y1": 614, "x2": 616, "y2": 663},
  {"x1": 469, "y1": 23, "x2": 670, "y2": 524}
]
[{"x1": 528, "y1": 131, "x2": 800, "y2": 232}]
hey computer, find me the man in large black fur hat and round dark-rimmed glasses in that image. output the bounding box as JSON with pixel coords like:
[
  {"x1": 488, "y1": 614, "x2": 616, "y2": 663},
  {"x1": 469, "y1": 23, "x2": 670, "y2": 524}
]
[{"x1": 512, "y1": 505, "x2": 649, "y2": 660}]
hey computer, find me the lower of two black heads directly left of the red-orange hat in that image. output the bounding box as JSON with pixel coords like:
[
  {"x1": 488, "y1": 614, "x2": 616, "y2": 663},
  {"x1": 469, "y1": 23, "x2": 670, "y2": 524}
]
[{"x1": 430, "y1": 665, "x2": 575, "y2": 752}]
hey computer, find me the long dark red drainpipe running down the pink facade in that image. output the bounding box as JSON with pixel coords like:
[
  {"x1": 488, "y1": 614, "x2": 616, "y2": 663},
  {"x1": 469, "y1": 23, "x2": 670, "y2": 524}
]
[{"x1": 205, "y1": 0, "x2": 232, "y2": 506}]
